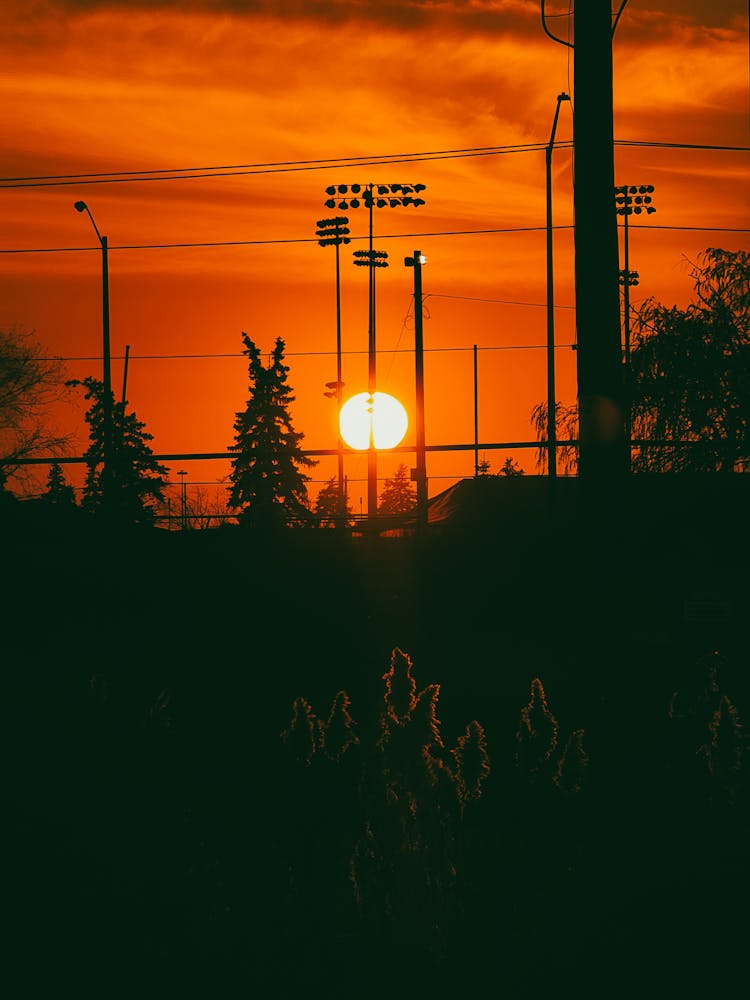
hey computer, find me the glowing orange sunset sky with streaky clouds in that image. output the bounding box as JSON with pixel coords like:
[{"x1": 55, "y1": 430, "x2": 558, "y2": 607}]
[{"x1": 0, "y1": 0, "x2": 750, "y2": 509}]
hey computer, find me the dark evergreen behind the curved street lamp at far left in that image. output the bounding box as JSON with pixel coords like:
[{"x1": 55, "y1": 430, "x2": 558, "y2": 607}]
[{"x1": 68, "y1": 376, "x2": 168, "y2": 524}]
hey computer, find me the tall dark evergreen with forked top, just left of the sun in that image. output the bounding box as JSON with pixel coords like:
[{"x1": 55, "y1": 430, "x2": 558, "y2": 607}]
[{"x1": 228, "y1": 333, "x2": 316, "y2": 529}]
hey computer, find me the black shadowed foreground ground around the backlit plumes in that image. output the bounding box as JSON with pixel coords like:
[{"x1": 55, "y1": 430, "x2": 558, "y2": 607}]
[{"x1": 5, "y1": 480, "x2": 750, "y2": 998}]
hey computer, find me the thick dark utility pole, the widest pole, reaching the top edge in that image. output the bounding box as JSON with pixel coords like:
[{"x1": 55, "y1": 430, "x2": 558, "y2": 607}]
[{"x1": 573, "y1": 0, "x2": 628, "y2": 492}]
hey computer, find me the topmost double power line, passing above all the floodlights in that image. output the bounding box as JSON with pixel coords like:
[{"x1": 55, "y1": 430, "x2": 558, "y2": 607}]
[{"x1": 0, "y1": 139, "x2": 750, "y2": 188}]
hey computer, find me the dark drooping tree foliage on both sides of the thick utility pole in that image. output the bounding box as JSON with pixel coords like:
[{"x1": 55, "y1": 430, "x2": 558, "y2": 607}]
[{"x1": 531, "y1": 248, "x2": 750, "y2": 472}]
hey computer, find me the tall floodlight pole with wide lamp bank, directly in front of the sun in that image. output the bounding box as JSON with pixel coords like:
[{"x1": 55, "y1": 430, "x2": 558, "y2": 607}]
[{"x1": 324, "y1": 182, "x2": 425, "y2": 517}]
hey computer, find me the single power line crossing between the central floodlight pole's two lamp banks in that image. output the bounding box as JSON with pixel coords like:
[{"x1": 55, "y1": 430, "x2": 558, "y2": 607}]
[{"x1": 0, "y1": 222, "x2": 750, "y2": 254}]
